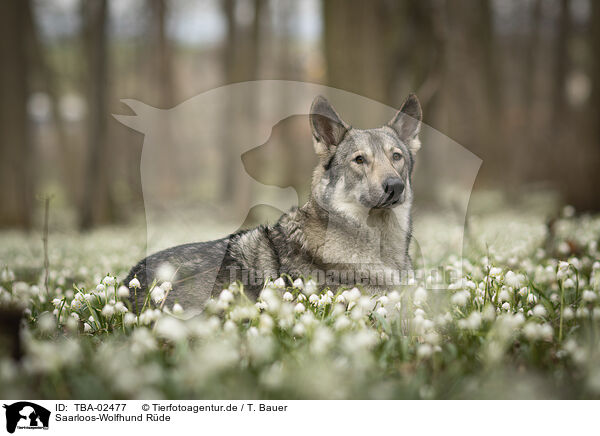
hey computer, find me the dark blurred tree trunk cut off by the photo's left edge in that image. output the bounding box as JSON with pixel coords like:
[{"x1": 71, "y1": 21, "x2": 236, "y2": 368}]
[{"x1": 0, "y1": 0, "x2": 34, "y2": 229}]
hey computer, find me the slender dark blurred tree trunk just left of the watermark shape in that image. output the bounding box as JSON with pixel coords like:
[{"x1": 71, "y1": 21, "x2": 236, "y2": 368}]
[{"x1": 80, "y1": 0, "x2": 113, "y2": 230}]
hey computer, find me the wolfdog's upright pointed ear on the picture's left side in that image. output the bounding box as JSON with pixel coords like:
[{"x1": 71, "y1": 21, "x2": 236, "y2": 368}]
[{"x1": 309, "y1": 95, "x2": 350, "y2": 155}]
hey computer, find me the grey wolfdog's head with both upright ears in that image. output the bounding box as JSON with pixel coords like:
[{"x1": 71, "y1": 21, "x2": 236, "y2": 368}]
[{"x1": 310, "y1": 94, "x2": 422, "y2": 217}]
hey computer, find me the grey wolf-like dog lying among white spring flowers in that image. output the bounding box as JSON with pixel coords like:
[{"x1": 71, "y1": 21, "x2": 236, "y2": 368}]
[{"x1": 125, "y1": 94, "x2": 422, "y2": 307}]
